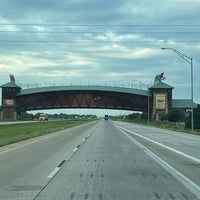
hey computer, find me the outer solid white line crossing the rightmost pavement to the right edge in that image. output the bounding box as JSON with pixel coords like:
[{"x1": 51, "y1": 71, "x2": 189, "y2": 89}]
[{"x1": 117, "y1": 126, "x2": 200, "y2": 163}]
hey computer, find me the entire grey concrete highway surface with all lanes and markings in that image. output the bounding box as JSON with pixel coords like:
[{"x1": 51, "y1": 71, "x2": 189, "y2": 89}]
[{"x1": 0, "y1": 120, "x2": 200, "y2": 200}]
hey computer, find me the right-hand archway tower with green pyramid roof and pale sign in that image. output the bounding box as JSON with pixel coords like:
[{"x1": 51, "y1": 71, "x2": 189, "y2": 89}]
[{"x1": 150, "y1": 81, "x2": 173, "y2": 121}]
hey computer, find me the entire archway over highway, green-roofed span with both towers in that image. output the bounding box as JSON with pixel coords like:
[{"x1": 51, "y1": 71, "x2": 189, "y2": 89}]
[{"x1": 0, "y1": 74, "x2": 184, "y2": 120}]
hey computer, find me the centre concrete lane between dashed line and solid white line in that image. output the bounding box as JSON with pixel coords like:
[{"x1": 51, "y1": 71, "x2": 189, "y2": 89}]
[{"x1": 34, "y1": 121, "x2": 198, "y2": 200}]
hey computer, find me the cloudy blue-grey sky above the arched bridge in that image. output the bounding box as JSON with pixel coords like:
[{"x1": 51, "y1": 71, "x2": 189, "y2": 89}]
[{"x1": 0, "y1": 0, "x2": 200, "y2": 115}]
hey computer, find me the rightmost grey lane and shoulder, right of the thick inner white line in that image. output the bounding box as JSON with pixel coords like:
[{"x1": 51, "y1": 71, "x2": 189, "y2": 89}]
[{"x1": 115, "y1": 122, "x2": 200, "y2": 193}]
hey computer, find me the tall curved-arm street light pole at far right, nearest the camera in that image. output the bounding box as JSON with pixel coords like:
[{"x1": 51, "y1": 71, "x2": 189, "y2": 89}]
[{"x1": 161, "y1": 48, "x2": 194, "y2": 132}]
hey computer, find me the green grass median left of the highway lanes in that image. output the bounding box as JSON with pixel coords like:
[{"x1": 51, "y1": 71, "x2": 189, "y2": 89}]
[{"x1": 0, "y1": 120, "x2": 91, "y2": 147}]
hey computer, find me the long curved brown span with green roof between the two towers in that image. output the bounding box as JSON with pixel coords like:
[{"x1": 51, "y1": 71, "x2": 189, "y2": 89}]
[{"x1": 16, "y1": 86, "x2": 149, "y2": 112}]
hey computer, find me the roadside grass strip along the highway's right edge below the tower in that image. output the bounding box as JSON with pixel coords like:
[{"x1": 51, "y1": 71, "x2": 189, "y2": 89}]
[{"x1": 122, "y1": 120, "x2": 200, "y2": 135}]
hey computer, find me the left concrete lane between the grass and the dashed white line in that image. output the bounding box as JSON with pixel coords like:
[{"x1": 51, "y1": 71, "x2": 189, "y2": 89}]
[{"x1": 0, "y1": 119, "x2": 98, "y2": 200}]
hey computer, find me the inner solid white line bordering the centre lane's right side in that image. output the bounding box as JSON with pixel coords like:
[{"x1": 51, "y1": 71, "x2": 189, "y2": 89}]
[{"x1": 119, "y1": 127, "x2": 200, "y2": 199}]
